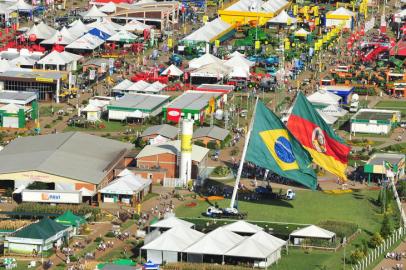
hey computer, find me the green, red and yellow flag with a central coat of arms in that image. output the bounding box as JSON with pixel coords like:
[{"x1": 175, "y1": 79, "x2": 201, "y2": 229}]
[{"x1": 287, "y1": 92, "x2": 350, "y2": 180}]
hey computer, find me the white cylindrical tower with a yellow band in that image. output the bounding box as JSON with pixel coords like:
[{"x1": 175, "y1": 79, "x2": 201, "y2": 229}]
[{"x1": 179, "y1": 119, "x2": 193, "y2": 186}]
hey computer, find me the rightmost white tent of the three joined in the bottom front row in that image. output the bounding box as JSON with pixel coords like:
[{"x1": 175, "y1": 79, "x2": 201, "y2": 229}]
[{"x1": 225, "y1": 231, "x2": 286, "y2": 268}]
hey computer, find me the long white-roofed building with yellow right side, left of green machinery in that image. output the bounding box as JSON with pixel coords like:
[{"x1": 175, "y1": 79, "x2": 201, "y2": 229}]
[{"x1": 182, "y1": 18, "x2": 234, "y2": 42}]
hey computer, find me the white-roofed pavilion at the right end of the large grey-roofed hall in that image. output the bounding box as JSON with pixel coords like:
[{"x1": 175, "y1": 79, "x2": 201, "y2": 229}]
[{"x1": 99, "y1": 173, "x2": 152, "y2": 204}]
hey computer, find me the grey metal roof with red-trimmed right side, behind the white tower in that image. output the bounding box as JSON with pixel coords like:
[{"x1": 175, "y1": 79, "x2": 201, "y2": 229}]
[{"x1": 167, "y1": 91, "x2": 222, "y2": 110}]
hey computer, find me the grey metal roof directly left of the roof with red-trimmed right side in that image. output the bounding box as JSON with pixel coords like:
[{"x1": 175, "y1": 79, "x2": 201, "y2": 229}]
[{"x1": 111, "y1": 94, "x2": 169, "y2": 110}]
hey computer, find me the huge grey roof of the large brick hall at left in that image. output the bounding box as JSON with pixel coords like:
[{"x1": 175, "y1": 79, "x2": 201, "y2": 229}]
[{"x1": 0, "y1": 132, "x2": 132, "y2": 184}]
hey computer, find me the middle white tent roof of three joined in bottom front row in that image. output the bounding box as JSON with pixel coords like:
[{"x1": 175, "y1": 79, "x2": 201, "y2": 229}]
[{"x1": 184, "y1": 227, "x2": 244, "y2": 255}]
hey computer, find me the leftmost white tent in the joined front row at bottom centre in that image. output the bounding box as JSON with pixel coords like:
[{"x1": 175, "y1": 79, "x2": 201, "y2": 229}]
[{"x1": 141, "y1": 225, "x2": 204, "y2": 264}]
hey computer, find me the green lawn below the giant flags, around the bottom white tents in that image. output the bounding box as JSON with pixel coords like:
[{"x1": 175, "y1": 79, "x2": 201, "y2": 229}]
[{"x1": 176, "y1": 190, "x2": 382, "y2": 270}]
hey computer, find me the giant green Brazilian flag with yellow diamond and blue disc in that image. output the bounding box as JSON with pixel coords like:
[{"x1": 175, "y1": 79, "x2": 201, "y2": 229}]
[{"x1": 245, "y1": 101, "x2": 317, "y2": 189}]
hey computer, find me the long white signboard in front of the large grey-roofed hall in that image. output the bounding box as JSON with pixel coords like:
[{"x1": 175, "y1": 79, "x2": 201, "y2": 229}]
[{"x1": 21, "y1": 190, "x2": 82, "y2": 203}]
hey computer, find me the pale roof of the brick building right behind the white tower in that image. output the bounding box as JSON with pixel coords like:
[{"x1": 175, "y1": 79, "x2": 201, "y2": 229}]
[{"x1": 137, "y1": 140, "x2": 209, "y2": 162}]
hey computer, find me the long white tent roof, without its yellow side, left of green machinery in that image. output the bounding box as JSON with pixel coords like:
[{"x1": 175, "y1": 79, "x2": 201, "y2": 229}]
[{"x1": 183, "y1": 18, "x2": 231, "y2": 42}]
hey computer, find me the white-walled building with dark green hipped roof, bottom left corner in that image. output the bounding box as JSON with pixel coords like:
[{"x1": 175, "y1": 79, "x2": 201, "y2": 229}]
[{"x1": 4, "y1": 217, "x2": 70, "y2": 254}]
